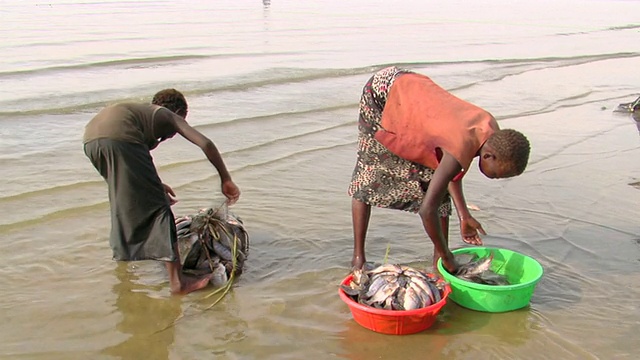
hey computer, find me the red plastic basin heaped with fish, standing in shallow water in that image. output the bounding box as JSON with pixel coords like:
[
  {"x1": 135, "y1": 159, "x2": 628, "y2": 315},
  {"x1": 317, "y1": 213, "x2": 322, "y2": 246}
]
[{"x1": 338, "y1": 274, "x2": 451, "y2": 335}]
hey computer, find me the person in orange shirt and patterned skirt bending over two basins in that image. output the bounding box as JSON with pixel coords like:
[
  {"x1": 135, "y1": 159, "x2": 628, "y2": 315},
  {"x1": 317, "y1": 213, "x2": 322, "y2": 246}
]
[{"x1": 348, "y1": 67, "x2": 530, "y2": 272}]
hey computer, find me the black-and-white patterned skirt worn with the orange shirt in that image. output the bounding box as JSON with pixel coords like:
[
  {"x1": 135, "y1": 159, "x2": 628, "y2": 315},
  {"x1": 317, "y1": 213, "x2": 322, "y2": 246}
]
[{"x1": 348, "y1": 67, "x2": 451, "y2": 217}]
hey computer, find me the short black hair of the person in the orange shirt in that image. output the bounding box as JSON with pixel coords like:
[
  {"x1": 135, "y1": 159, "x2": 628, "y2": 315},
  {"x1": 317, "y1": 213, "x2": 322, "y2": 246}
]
[{"x1": 487, "y1": 129, "x2": 531, "y2": 175}]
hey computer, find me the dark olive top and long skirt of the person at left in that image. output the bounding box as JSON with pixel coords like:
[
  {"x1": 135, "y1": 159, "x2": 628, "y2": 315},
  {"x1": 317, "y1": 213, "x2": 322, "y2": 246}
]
[{"x1": 83, "y1": 103, "x2": 178, "y2": 261}]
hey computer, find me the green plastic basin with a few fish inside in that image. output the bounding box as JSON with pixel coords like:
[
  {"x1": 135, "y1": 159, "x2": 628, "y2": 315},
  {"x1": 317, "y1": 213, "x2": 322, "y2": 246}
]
[{"x1": 437, "y1": 247, "x2": 543, "y2": 313}]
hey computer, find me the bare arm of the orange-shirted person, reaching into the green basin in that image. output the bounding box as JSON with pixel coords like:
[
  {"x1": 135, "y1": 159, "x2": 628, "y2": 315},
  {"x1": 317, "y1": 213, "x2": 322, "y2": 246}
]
[{"x1": 419, "y1": 152, "x2": 461, "y2": 270}]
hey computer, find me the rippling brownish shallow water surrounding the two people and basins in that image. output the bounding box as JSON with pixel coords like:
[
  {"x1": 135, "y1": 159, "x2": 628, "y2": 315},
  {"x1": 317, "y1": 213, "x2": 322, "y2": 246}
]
[{"x1": 0, "y1": 0, "x2": 640, "y2": 359}]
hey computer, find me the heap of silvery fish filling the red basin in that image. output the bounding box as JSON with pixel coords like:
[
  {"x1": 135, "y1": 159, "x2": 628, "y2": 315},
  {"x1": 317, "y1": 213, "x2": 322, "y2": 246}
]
[{"x1": 341, "y1": 264, "x2": 444, "y2": 310}]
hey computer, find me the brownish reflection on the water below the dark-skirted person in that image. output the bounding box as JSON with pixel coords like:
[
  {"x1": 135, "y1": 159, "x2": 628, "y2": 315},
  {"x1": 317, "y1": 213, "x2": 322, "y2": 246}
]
[{"x1": 102, "y1": 262, "x2": 182, "y2": 360}]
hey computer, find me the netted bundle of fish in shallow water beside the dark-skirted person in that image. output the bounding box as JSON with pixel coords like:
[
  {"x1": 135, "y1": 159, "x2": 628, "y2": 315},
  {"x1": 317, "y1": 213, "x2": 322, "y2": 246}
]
[{"x1": 176, "y1": 208, "x2": 249, "y2": 287}]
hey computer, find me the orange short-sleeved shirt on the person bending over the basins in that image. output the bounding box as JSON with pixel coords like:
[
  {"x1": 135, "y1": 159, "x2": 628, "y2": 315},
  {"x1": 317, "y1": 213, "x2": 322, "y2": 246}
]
[{"x1": 375, "y1": 73, "x2": 499, "y2": 180}]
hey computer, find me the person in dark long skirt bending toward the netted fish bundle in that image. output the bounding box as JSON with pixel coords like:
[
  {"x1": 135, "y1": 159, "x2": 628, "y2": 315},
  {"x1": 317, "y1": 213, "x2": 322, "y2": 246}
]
[{"x1": 83, "y1": 89, "x2": 240, "y2": 294}]
